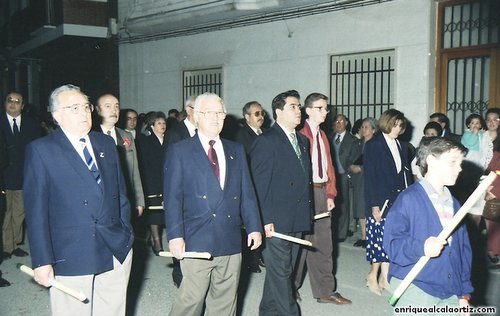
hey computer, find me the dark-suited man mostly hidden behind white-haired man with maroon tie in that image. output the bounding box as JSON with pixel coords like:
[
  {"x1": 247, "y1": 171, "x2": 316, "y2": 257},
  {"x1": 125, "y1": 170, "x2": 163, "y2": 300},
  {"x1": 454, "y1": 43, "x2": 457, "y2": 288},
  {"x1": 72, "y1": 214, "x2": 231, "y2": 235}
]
[{"x1": 165, "y1": 96, "x2": 196, "y2": 287}]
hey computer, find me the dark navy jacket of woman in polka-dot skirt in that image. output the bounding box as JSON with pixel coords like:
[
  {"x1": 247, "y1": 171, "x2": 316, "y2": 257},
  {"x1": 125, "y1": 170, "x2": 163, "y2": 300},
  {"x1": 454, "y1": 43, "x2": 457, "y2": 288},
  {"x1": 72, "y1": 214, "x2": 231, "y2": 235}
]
[{"x1": 363, "y1": 133, "x2": 413, "y2": 210}]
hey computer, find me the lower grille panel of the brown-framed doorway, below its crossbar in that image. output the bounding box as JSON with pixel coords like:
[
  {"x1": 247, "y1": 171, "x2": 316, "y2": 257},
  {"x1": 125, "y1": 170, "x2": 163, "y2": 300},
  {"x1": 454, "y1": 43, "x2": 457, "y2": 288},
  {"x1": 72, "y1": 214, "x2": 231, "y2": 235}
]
[{"x1": 446, "y1": 56, "x2": 490, "y2": 134}]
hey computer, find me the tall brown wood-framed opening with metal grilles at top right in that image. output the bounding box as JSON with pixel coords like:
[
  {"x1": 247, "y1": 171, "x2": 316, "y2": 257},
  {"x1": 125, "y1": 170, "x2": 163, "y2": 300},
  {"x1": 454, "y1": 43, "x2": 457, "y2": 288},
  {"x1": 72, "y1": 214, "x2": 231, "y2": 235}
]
[{"x1": 436, "y1": 0, "x2": 500, "y2": 134}]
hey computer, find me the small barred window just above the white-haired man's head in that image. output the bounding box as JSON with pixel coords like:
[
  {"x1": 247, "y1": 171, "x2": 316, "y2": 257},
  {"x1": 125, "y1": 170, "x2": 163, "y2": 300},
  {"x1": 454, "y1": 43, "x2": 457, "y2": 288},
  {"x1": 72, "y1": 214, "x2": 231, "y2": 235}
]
[{"x1": 182, "y1": 67, "x2": 222, "y2": 100}]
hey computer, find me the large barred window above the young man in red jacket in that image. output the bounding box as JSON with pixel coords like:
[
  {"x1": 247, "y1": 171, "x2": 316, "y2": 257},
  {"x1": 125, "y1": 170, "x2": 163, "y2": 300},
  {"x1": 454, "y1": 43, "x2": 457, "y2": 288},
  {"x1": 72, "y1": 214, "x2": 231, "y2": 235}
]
[{"x1": 330, "y1": 50, "x2": 395, "y2": 123}]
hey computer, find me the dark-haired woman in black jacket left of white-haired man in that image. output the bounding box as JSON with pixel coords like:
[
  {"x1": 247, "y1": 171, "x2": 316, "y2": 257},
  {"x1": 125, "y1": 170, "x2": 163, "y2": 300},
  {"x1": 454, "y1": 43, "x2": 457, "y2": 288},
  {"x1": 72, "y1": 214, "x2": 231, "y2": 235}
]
[{"x1": 140, "y1": 112, "x2": 167, "y2": 256}]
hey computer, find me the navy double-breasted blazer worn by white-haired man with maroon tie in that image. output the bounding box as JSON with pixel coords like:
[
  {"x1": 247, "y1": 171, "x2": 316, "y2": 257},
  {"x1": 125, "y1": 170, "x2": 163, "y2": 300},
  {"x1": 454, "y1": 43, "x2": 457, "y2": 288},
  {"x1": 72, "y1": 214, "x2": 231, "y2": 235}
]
[{"x1": 163, "y1": 136, "x2": 262, "y2": 257}]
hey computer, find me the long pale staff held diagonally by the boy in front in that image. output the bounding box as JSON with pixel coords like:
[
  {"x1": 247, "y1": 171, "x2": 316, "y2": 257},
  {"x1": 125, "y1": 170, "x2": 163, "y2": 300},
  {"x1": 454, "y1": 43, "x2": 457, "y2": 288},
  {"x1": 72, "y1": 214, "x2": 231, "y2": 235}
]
[{"x1": 389, "y1": 171, "x2": 496, "y2": 306}]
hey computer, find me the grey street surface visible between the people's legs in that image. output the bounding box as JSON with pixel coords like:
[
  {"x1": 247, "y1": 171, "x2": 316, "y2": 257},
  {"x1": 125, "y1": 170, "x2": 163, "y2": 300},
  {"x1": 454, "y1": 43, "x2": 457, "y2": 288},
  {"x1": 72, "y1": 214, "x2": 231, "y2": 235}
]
[{"x1": 0, "y1": 231, "x2": 500, "y2": 316}]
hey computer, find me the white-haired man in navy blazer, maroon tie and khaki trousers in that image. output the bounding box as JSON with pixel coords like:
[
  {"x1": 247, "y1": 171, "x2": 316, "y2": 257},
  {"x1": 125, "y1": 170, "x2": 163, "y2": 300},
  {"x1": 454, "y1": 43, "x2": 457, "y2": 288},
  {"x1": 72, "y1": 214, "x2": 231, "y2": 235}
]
[{"x1": 163, "y1": 93, "x2": 262, "y2": 316}]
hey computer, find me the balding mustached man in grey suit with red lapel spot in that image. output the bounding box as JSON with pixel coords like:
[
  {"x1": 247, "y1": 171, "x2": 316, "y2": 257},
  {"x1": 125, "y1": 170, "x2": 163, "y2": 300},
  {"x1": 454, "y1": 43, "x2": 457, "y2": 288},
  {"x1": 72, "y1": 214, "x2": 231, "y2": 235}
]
[{"x1": 96, "y1": 94, "x2": 144, "y2": 216}]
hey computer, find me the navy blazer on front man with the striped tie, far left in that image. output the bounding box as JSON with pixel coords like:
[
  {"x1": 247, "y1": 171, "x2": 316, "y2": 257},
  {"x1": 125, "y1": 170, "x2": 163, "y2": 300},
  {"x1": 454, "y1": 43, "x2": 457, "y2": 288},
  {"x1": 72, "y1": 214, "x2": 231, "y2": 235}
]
[{"x1": 23, "y1": 128, "x2": 134, "y2": 276}]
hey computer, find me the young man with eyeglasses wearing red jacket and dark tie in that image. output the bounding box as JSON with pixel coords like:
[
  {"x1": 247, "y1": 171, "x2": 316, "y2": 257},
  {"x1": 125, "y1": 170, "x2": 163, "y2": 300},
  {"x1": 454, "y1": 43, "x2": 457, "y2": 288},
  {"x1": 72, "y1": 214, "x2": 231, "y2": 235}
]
[{"x1": 295, "y1": 93, "x2": 351, "y2": 305}]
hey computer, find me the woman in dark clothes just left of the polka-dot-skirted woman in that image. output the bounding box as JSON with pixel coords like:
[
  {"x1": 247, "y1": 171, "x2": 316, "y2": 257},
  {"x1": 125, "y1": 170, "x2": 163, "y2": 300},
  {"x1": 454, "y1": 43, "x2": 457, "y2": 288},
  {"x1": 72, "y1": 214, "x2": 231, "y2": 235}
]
[{"x1": 348, "y1": 117, "x2": 378, "y2": 248}]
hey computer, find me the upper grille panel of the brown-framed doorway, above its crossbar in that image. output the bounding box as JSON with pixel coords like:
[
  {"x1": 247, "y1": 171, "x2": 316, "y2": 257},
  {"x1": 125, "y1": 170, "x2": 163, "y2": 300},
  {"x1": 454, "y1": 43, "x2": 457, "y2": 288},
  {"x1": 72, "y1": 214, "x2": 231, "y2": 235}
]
[{"x1": 442, "y1": 0, "x2": 500, "y2": 48}]
